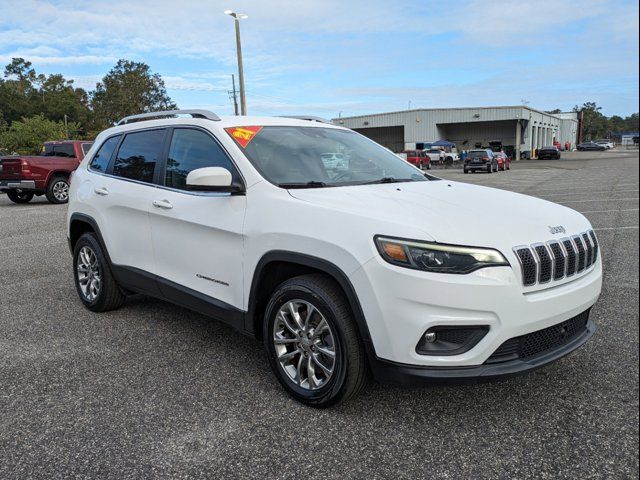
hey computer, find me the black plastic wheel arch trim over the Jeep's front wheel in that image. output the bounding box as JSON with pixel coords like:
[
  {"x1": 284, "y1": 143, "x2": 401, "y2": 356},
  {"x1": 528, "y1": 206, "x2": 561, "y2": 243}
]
[{"x1": 245, "y1": 250, "x2": 373, "y2": 353}]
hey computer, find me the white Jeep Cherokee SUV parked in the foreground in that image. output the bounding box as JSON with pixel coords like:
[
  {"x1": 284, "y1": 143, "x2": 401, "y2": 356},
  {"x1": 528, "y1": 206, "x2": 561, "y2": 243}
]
[{"x1": 67, "y1": 110, "x2": 602, "y2": 407}]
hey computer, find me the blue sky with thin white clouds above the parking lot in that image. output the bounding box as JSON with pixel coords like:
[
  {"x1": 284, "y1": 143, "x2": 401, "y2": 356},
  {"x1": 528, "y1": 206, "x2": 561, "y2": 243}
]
[{"x1": 0, "y1": 0, "x2": 638, "y2": 117}]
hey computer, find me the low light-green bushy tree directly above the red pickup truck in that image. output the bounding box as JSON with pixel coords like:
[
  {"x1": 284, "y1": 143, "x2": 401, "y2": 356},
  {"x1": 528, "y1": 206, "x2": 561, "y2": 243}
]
[{"x1": 0, "y1": 115, "x2": 80, "y2": 155}]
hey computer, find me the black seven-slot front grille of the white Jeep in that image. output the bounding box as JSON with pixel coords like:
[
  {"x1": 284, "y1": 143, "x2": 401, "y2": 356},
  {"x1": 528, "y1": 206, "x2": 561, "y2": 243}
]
[{"x1": 513, "y1": 230, "x2": 598, "y2": 287}]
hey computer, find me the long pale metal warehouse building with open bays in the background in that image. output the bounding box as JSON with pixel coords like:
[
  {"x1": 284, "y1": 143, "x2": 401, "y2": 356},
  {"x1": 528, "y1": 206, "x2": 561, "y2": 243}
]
[{"x1": 333, "y1": 105, "x2": 578, "y2": 157}]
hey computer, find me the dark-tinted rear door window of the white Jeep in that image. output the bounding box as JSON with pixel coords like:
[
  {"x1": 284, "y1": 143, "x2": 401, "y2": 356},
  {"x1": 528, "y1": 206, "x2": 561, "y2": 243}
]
[{"x1": 113, "y1": 130, "x2": 165, "y2": 183}]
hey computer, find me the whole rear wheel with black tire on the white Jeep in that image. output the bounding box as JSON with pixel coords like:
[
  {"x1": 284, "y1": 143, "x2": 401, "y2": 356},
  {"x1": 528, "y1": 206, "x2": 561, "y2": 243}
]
[{"x1": 73, "y1": 233, "x2": 126, "y2": 312}]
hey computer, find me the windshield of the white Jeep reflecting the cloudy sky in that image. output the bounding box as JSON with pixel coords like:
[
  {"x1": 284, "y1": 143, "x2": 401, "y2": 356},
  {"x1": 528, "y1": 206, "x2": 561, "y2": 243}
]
[{"x1": 231, "y1": 127, "x2": 427, "y2": 188}]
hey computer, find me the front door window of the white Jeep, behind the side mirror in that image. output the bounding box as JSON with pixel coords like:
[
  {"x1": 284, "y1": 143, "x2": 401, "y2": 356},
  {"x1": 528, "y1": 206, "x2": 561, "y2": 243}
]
[{"x1": 164, "y1": 128, "x2": 237, "y2": 190}]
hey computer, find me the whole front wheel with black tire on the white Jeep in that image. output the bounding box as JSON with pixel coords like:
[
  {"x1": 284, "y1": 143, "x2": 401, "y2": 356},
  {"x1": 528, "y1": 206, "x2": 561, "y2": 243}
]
[{"x1": 263, "y1": 274, "x2": 368, "y2": 408}]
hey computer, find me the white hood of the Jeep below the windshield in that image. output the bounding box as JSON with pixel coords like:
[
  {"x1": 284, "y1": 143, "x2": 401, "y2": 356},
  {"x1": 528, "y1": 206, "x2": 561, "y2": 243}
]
[{"x1": 290, "y1": 180, "x2": 591, "y2": 250}]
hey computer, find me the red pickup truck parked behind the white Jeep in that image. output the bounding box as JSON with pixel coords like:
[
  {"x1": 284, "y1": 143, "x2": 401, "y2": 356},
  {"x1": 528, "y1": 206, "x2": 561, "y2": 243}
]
[{"x1": 0, "y1": 140, "x2": 93, "y2": 203}]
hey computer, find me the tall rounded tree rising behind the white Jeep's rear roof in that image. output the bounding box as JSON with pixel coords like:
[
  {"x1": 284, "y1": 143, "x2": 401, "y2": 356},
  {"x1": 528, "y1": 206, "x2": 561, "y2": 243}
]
[{"x1": 91, "y1": 59, "x2": 177, "y2": 127}]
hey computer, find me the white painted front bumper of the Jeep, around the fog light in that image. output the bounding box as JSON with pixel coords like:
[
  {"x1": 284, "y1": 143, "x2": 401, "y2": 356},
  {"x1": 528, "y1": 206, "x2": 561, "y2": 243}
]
[{"x1": 350, "y1": 257, "x2": 602, "y2": 370}]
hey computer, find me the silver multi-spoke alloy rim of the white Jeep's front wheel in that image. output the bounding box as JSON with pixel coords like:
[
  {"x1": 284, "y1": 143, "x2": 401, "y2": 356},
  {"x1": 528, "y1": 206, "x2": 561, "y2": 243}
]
[{"x1": 272, "y1": 300, "x2": 336, "y2": 390}]
